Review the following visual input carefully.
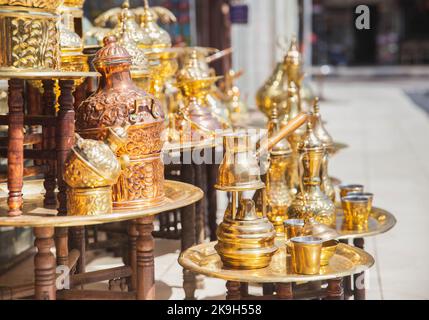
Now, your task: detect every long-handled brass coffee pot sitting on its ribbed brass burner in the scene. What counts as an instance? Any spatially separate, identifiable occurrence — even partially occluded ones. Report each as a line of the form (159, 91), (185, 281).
(215, 113), (308, 269)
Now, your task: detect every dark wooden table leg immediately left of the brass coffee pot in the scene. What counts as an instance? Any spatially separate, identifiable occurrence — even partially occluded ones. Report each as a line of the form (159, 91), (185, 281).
(206, 161), (219, 241)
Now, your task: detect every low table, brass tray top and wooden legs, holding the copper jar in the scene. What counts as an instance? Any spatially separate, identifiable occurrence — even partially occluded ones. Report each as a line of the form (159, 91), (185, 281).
(0, 180), (203, 300)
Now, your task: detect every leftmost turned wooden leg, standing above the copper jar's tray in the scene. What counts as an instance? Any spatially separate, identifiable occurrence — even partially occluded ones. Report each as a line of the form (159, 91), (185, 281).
(7, 79), (24, 216)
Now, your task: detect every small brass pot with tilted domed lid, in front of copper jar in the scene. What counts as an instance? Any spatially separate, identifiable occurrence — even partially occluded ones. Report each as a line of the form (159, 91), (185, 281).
(64, 128), (128, 216)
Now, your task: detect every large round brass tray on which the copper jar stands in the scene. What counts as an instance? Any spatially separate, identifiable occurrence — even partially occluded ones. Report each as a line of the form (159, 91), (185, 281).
(0, 180), (204, 227)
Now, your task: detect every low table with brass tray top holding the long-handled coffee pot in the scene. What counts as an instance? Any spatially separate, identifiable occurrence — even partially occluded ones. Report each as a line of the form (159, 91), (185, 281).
(179, 242), (374, 300)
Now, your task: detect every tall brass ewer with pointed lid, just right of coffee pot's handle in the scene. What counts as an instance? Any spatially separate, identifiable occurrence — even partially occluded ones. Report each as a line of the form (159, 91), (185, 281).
(288, 122), (336, 226)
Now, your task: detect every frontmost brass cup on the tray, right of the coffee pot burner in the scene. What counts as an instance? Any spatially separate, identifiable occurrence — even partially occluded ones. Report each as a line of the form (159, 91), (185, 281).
(291, 236), (323, 275)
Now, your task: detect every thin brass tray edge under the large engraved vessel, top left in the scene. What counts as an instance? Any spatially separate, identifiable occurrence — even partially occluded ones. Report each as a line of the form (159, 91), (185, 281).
(0, 71), (100, 80)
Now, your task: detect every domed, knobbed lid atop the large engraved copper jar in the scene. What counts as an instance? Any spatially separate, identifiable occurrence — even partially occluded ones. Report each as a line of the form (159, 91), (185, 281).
(93, 36), (132, 66)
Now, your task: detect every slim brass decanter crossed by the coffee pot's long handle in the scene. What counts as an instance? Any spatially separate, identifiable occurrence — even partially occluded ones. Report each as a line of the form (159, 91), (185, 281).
(266, 107), (293, 235)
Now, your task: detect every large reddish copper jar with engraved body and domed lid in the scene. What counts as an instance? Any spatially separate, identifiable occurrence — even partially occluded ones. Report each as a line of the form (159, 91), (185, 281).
(76, 36), (164, 208)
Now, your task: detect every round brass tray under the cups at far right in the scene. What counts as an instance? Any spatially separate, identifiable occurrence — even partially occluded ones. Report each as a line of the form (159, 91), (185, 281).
(337, 207), (396, 239)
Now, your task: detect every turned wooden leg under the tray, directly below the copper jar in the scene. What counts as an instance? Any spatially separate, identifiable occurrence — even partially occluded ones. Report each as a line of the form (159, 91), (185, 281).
(136, 216), (155, 300)
